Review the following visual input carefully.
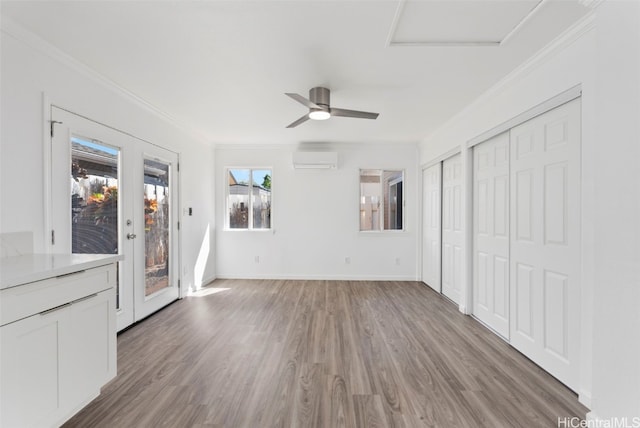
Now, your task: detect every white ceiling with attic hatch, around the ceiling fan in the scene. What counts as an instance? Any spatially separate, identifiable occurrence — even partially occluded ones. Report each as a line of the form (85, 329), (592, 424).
(1, 0), (587, 144)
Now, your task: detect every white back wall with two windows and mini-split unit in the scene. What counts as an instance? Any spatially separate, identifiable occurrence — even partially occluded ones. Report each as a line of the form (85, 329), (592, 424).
(215, 144), (419, 280)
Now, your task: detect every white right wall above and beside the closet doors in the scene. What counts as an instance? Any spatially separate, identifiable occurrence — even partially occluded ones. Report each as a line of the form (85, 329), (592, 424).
(420, 0), (640, 419)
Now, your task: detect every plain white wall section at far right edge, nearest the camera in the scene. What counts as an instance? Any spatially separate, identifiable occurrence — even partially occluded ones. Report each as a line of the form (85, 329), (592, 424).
(592, 1), (640, 424)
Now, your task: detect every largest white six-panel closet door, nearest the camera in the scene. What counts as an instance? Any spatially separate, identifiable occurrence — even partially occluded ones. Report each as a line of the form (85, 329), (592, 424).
(510, 100), (580, 390)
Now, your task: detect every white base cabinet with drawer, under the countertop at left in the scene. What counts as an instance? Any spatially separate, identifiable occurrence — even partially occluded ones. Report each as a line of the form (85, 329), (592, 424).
(0, 263), (116, 428)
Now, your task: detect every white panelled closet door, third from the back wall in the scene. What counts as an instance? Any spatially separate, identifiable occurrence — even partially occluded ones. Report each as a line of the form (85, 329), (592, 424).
(473, 132), (509, 339)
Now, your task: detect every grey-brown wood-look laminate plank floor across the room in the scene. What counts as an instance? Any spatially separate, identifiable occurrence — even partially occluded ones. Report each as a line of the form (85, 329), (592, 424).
(65, 280), (586, 428)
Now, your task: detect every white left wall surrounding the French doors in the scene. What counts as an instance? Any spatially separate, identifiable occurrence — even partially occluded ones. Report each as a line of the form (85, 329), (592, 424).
(0, 18), (215, 286)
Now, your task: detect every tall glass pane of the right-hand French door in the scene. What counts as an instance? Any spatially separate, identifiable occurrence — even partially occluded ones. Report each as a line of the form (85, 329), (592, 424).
(144, 159), (171, 297)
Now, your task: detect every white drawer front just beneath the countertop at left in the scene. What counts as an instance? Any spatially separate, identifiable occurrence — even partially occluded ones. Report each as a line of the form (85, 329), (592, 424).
(0, 264), (116, 325)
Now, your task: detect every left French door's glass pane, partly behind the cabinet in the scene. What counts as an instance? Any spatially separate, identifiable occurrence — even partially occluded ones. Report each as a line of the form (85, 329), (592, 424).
(71, 137), (120, 308)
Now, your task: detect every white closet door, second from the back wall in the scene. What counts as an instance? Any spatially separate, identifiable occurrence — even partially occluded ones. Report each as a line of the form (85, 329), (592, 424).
(442, 155), (464, 304)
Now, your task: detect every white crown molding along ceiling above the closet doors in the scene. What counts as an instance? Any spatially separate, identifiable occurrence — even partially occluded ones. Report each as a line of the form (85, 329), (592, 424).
(421, 8), (603, 144)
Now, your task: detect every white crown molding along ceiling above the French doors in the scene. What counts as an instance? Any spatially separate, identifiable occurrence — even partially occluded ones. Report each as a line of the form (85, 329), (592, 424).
(0, 15), (210, 144)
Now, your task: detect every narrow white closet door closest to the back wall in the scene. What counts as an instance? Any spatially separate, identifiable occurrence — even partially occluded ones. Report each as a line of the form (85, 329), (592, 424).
(422, 163), (441, 292)
